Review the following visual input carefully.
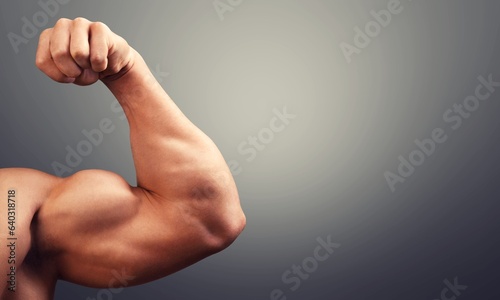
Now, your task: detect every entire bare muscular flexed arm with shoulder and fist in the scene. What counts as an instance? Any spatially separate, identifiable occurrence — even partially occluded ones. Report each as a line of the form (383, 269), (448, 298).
(0, 18), (246, 300)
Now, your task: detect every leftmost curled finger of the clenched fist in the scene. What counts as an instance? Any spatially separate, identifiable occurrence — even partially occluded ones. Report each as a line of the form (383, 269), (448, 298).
(36, 28), (75, 83)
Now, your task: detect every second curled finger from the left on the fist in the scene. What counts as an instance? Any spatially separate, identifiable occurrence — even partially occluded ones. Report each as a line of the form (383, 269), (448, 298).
(50, 19), (82, 78)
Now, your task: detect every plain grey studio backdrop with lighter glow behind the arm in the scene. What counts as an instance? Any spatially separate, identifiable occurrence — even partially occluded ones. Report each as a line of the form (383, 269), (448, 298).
(0, 0), (500, 300)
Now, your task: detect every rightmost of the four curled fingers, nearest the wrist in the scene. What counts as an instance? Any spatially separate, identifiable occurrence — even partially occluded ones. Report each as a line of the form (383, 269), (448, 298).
(90, 22), (111, 73)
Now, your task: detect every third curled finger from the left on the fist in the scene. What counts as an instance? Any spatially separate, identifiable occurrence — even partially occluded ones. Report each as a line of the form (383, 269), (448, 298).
(70, 18), (91, 69)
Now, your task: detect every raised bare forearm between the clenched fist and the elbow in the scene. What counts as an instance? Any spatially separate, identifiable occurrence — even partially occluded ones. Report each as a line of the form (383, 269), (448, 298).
(103, 51), (234, 196)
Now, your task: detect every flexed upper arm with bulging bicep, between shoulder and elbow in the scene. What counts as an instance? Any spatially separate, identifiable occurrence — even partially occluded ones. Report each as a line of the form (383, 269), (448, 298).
(37, 170), (223, 288)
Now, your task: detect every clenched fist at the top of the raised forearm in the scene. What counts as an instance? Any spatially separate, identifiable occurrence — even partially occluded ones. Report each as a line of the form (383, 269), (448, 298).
(36, 18), (135, 85)
